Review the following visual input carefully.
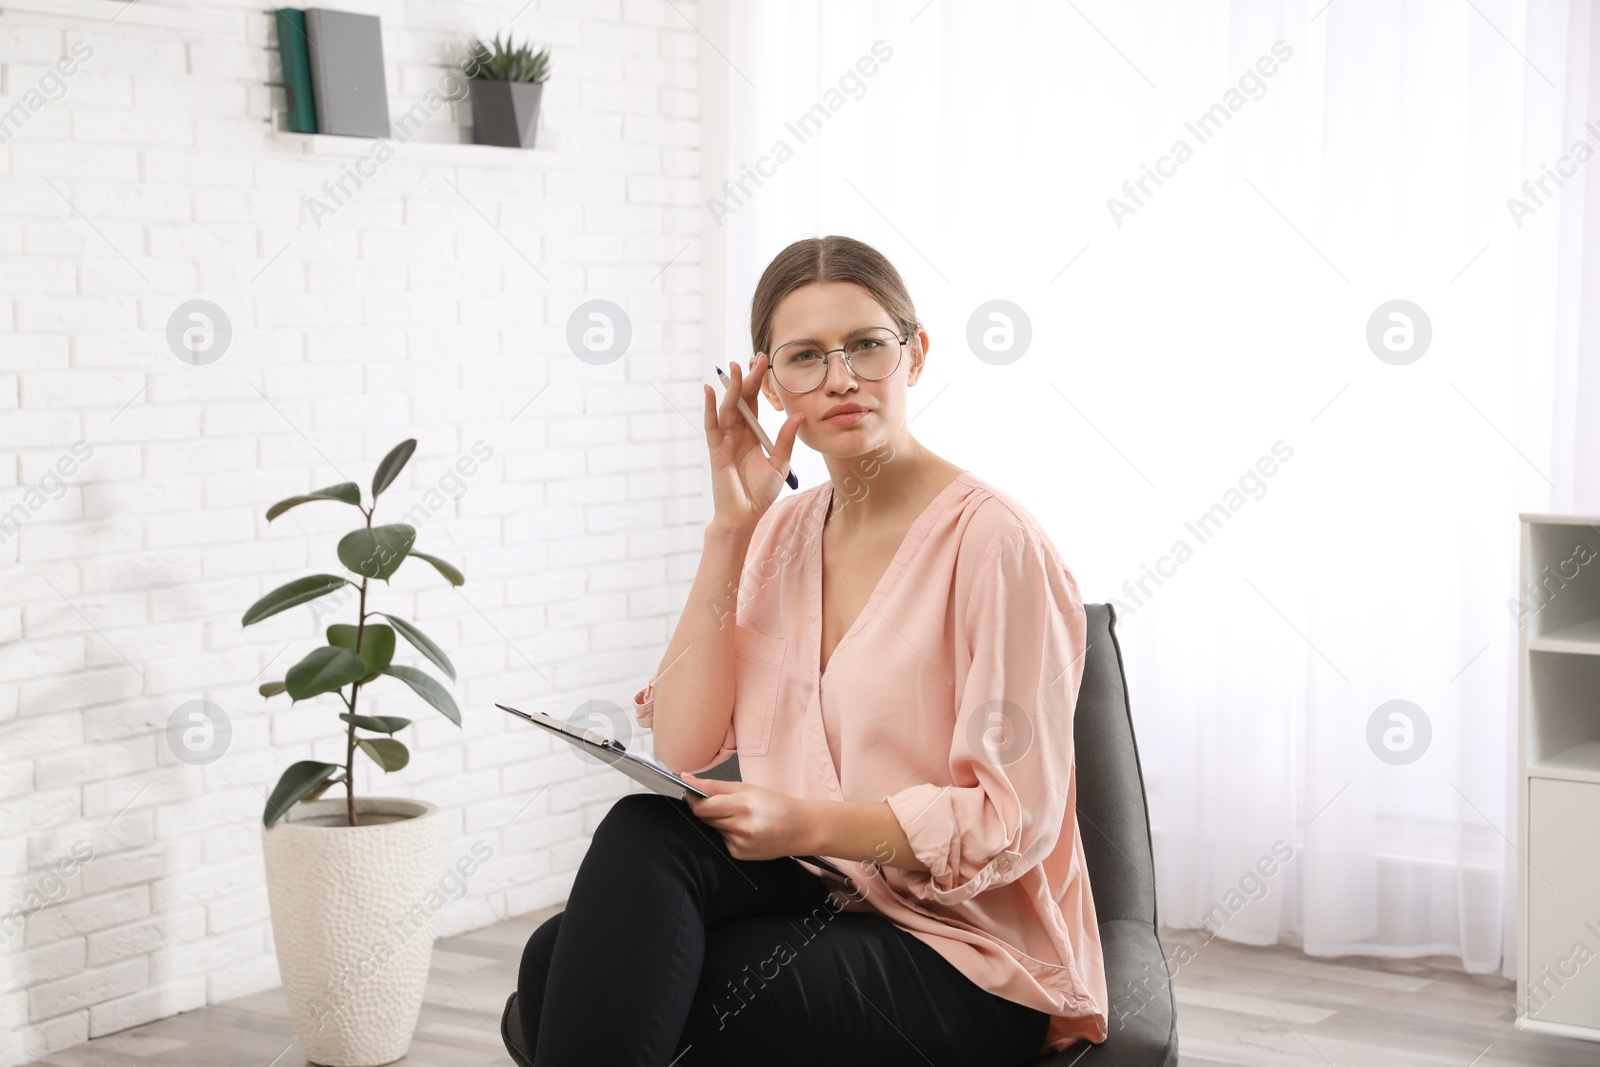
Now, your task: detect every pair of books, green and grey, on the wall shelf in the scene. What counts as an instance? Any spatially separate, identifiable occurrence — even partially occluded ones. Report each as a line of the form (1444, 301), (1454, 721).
(274, 8), (389, 138)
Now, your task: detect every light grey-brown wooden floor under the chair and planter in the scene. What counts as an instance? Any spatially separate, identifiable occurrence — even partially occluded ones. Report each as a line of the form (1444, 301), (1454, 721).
(15, 909), (1600, 1067)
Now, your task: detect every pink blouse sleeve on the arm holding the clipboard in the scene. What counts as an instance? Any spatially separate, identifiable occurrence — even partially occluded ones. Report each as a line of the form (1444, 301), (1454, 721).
(883, 530), (1088, 904)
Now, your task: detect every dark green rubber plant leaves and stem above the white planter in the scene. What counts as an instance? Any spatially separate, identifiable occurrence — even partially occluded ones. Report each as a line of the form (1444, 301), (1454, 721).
(242, 438), (466, 827)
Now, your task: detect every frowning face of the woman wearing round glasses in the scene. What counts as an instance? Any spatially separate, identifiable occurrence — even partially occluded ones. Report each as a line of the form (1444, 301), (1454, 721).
(762, 282), (928, 458)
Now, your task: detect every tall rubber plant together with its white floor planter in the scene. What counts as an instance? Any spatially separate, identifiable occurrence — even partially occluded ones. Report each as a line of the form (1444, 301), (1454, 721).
(242, 438), (466, 1067)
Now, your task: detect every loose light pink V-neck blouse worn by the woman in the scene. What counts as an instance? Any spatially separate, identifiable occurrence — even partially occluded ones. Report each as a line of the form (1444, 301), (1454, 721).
(634, 470), (1107, 1053)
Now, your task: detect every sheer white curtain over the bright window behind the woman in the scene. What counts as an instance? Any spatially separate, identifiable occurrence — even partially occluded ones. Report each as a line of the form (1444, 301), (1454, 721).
(701, 0), (1600, 974)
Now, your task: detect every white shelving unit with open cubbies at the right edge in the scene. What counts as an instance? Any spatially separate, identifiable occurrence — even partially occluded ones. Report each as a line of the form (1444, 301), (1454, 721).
(1514, 515), (1600, 1041)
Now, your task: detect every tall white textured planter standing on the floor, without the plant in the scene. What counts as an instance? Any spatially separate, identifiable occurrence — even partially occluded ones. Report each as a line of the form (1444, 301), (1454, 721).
(261, 797), (440, 1067)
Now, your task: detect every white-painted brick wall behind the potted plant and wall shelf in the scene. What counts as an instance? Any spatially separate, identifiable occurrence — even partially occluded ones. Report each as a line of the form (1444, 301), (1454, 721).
(0, 0), (706, 1067)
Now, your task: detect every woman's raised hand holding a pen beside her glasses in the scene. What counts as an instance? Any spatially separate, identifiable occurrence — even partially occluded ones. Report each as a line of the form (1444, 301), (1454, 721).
(706, 352), (805, 531)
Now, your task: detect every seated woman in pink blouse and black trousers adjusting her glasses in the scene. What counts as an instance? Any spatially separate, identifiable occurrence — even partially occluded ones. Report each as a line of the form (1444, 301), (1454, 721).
(504, 237), (1107, 1067)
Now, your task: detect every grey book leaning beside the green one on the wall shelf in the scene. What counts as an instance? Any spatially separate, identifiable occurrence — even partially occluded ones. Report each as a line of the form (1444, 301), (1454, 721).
(306, 8), (389, 138)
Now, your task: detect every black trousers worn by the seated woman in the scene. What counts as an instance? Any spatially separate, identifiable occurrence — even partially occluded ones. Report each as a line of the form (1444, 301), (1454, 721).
(517, 793), (1050, 1067)
